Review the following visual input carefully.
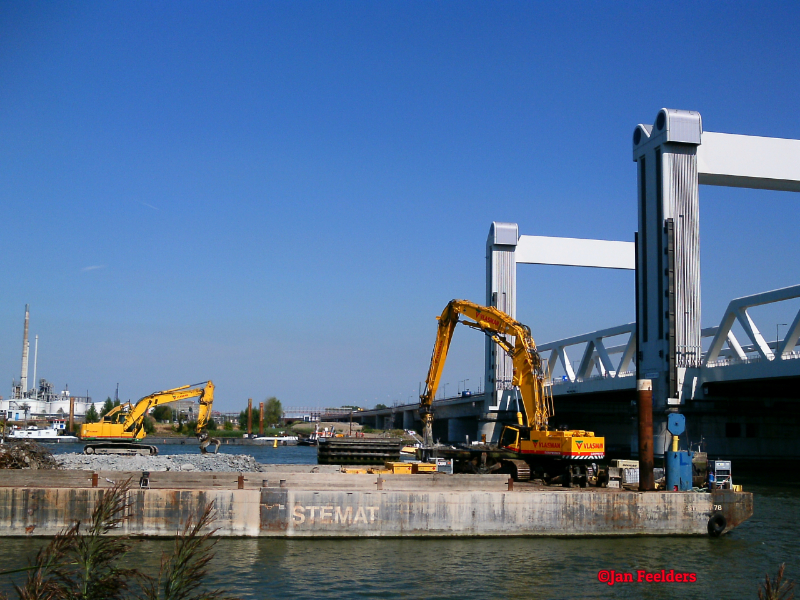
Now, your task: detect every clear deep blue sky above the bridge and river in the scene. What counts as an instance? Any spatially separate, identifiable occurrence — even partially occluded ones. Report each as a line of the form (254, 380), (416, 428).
(0, 1), (800, 410)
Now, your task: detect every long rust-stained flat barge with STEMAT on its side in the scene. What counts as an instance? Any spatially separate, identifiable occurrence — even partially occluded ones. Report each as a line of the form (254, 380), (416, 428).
(0, 465), (753, 538)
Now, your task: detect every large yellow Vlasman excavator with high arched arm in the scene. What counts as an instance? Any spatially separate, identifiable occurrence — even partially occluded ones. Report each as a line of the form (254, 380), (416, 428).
(419, 300), (605, 485)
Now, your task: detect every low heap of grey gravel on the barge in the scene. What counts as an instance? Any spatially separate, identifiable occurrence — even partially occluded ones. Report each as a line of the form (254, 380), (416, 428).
(55, 453), (263, 472)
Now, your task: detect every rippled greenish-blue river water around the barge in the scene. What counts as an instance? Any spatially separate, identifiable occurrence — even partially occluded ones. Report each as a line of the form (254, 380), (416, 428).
(0, 444), (800, 600)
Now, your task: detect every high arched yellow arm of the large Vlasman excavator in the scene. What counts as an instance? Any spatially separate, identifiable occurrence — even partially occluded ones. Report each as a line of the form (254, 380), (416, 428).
(419, 300), (553, 446)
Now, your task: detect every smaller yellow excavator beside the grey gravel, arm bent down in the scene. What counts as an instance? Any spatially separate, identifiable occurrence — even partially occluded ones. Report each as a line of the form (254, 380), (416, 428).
(80, 381), (220, 455)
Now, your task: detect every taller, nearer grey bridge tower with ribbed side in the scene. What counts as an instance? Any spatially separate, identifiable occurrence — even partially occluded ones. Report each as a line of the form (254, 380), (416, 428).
(633, 109), (703, 448)
